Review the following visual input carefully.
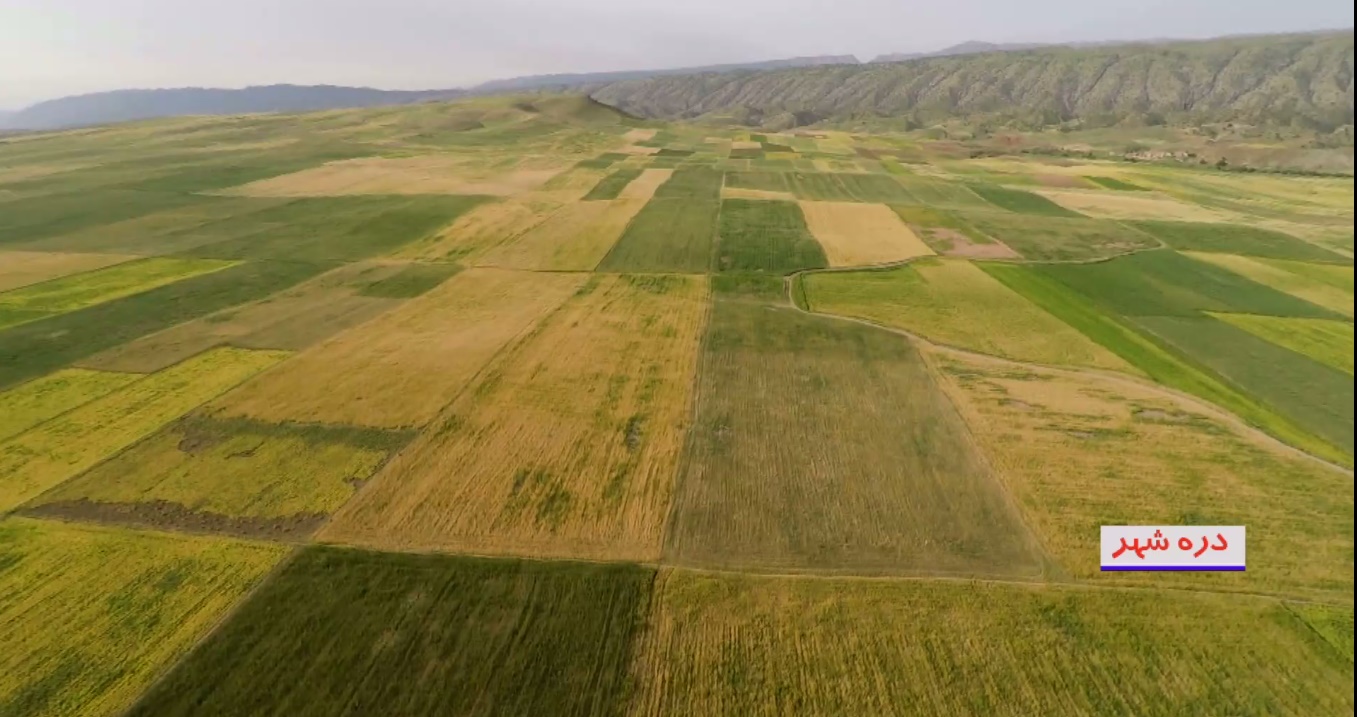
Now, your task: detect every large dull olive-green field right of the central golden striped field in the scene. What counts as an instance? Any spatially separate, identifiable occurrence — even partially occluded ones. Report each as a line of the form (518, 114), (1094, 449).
(665, 300), (1038, 574)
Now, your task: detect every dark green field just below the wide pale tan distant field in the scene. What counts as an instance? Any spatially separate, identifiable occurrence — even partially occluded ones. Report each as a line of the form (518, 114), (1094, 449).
(186, 196), (487, 262)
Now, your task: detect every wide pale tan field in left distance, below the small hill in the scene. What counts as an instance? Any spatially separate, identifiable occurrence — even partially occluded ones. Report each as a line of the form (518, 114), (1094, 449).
(224, 155), (560, 197)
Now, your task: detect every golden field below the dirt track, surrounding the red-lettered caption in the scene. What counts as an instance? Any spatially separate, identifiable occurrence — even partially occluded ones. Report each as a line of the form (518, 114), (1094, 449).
(934, 353), (1353, 599)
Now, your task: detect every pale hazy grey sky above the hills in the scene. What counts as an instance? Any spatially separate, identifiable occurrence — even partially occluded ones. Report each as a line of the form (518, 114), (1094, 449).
(0, 0), (1353, 109)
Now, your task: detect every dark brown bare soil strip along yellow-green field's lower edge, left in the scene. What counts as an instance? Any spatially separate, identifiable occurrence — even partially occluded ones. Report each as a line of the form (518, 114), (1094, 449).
(23, 498), (328, 540)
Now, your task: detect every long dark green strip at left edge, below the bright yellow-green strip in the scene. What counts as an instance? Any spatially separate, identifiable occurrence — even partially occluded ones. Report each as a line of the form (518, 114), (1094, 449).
(0, 262), (328, 387)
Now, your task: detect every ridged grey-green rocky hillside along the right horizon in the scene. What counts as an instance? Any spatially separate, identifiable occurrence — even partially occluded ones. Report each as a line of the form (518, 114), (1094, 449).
(593, 31), (1353, 130)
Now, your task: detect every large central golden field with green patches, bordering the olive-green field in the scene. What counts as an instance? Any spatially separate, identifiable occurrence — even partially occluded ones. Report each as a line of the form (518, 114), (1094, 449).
(320, 276), (707, 559)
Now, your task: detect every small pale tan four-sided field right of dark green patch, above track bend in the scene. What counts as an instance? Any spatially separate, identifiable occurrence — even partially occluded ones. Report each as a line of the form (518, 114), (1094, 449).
(799, 201), (934, 266)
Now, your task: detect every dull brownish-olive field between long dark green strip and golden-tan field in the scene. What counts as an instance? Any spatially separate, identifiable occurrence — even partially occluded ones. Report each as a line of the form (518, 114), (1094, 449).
(77, 262), (402, 373)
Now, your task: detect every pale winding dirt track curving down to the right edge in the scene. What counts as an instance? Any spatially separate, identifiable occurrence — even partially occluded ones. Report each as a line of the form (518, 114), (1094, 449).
(783, 262), (1354, 478)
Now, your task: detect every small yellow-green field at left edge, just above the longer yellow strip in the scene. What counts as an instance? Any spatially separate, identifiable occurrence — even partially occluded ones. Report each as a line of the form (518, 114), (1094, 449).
(0, 368), (141, 441)
